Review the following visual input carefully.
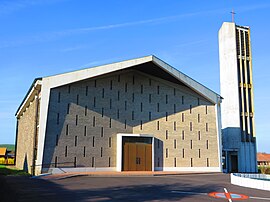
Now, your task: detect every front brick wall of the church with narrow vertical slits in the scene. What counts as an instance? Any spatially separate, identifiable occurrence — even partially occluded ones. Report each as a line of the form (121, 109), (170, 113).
(43, 70), (219, 172)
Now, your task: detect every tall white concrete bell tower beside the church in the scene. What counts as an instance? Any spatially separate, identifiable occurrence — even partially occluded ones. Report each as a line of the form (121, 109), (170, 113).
(219, 22), (257, 172)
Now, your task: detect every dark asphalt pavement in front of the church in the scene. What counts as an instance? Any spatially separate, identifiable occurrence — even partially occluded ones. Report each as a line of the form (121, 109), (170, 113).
(0, 174), (270, 202)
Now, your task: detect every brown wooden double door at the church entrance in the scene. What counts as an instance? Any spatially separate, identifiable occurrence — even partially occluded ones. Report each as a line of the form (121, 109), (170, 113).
(123, 142), (152, 171)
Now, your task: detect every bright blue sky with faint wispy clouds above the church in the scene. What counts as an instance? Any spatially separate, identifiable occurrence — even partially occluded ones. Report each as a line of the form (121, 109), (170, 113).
(0, 0), (270, 153)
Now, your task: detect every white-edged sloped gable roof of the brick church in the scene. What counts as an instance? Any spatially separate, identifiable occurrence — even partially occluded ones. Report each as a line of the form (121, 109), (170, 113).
(16, 55), (222, 116)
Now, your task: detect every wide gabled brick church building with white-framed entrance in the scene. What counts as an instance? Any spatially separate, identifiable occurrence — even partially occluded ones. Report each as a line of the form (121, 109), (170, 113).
(13, 55), (223, 175)
